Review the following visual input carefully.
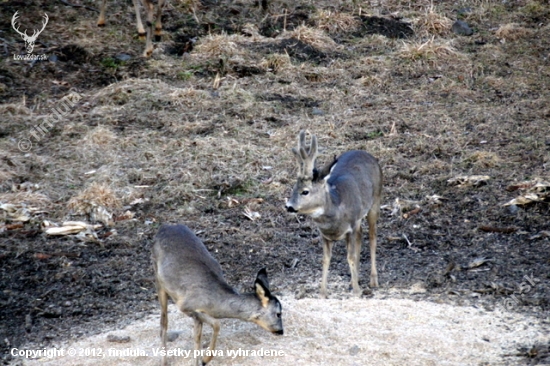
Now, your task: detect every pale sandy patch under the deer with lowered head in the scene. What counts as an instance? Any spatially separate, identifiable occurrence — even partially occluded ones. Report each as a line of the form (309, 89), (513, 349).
(18, 297), (550, 365)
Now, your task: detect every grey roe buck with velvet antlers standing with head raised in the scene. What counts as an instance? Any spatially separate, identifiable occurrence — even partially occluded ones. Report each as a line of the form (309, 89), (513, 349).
(286, 131), (382, 298)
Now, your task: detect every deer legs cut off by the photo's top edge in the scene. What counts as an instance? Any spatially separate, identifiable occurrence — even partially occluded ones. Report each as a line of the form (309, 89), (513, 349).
(97, 0), (165, 57)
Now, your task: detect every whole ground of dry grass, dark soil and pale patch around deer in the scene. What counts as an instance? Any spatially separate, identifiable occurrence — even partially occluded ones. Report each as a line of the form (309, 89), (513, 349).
(0, 0), (550, 365)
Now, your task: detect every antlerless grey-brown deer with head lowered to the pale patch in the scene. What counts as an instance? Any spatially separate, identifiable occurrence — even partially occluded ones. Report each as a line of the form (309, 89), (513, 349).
(151, 225), (283, 366)
